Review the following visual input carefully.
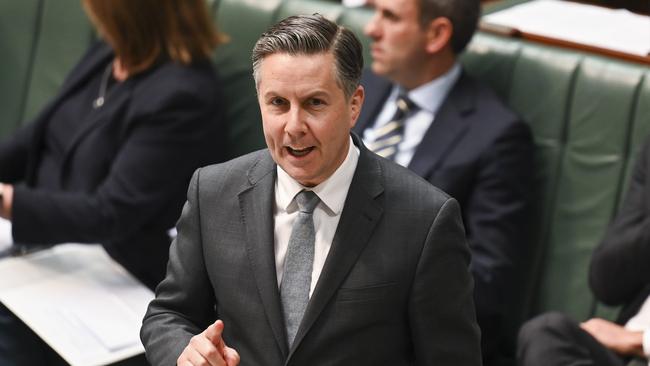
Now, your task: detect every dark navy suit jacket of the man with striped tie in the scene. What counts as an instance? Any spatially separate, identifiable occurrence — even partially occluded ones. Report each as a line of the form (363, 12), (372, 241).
(355, 71), (533, 357)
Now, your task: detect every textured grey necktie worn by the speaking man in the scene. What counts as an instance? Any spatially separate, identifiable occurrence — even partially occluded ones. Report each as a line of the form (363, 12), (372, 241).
(280, 191), (319, 346)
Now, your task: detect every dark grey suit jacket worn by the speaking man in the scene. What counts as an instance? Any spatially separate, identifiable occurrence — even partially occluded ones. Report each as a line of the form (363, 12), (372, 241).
(141, 136), (481, 366)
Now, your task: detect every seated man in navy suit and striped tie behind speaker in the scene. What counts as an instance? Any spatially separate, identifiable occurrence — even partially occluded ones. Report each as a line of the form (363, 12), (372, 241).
(354, 0), (533, 364)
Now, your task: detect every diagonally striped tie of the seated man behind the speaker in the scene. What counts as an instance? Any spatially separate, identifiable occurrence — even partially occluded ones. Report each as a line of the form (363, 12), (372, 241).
(369, 92), (418, 160)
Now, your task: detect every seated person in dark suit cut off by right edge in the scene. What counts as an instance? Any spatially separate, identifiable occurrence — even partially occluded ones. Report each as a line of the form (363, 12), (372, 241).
(518, 140), (650, 366)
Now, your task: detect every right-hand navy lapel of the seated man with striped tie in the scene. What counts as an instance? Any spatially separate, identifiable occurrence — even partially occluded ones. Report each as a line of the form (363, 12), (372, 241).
(408, 73), (476, 177)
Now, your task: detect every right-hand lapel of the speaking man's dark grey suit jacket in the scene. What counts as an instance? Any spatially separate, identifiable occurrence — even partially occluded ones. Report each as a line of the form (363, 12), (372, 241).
(288, 135), (383, 359)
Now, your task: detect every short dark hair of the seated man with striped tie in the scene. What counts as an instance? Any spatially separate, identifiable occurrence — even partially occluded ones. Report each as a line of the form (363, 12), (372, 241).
(418, 0), (481, 55)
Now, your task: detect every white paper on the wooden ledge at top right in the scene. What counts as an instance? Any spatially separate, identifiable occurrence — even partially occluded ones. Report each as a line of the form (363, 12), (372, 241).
(481, 0), (650, 56)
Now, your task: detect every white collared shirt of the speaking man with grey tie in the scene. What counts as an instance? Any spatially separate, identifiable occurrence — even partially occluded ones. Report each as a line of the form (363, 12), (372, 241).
(274, 138), (359, 297)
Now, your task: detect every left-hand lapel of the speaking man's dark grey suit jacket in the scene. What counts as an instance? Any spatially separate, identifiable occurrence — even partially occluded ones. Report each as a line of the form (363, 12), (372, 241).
(239, 154), (288, 356)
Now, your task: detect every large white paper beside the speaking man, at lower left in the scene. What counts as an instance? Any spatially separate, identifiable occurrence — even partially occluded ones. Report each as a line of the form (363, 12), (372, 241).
(0, 244), (154, 366)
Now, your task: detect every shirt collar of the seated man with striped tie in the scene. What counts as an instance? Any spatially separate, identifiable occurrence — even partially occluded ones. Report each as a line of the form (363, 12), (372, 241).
(391, 62), (461, 115)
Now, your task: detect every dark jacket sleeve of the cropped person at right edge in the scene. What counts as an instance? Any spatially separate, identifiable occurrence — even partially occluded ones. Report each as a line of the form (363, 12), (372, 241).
(589, 139), (650, 324)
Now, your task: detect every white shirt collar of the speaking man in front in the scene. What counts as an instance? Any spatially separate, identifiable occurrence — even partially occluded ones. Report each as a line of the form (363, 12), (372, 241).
(275, 137), (359, 215)
